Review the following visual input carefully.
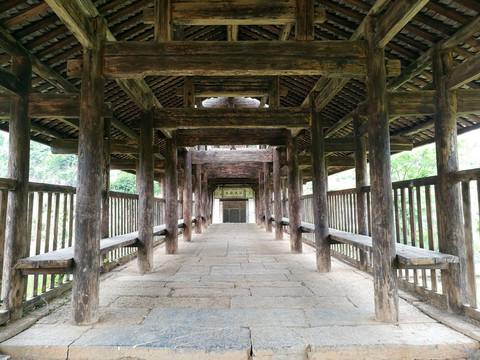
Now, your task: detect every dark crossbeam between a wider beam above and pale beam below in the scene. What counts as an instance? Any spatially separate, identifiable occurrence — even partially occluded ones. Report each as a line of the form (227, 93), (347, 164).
(177, 129), (289, 146)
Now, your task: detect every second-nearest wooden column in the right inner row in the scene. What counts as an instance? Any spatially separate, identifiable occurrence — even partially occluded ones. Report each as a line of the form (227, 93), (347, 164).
(310, 100), (331, 272)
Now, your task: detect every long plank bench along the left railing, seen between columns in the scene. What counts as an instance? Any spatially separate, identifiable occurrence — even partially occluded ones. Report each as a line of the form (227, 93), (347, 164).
(15, 219), (185, 275)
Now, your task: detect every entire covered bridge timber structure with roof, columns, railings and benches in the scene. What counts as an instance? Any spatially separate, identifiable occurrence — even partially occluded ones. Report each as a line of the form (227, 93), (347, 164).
(0, 0), (480, 352)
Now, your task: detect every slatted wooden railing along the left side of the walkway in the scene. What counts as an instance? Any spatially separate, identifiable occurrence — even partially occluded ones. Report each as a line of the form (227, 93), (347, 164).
(0, 179), (172, 316)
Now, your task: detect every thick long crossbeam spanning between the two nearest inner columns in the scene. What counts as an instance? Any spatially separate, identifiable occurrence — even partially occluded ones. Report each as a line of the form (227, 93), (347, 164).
(104, 41), (366, 79)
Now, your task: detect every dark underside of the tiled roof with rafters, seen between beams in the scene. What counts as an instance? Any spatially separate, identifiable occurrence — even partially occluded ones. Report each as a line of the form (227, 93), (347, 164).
(0, 0), (480, 173)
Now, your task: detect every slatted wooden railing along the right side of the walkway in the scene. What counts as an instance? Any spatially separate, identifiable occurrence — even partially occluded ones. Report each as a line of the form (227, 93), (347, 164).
(302, 169), (480, 318)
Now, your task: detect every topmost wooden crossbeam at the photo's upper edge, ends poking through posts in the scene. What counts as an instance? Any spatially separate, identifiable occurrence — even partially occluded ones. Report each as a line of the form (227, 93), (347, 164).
(143, 0), (326, 26)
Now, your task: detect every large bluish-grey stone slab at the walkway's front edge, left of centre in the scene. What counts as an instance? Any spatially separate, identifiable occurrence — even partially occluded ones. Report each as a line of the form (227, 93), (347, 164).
(68, 325), (251, 360)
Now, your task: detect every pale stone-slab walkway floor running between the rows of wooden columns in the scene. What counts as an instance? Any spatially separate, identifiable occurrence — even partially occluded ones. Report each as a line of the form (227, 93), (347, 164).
(0, 224), (480, 360)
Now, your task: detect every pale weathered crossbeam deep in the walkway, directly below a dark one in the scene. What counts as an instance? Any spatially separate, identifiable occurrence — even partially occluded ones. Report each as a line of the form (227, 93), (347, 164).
(192, 149), (272, 164)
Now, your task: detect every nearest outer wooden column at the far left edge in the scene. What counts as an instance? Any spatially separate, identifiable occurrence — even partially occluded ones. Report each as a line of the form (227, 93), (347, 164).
(2, 57), (32, 320)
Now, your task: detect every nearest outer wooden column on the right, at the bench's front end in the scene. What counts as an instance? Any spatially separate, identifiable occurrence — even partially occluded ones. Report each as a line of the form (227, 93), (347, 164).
(433, 51), (468, 313)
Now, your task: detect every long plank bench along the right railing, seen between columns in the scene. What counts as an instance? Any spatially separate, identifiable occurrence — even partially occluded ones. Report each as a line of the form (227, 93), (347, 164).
(272, 218), (459, 269)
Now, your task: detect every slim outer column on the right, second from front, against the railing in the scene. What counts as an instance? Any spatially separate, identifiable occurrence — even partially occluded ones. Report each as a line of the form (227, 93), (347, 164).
(353, 115), (368, 271)
